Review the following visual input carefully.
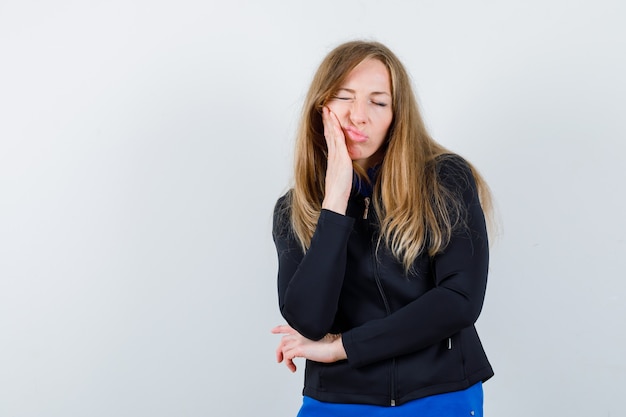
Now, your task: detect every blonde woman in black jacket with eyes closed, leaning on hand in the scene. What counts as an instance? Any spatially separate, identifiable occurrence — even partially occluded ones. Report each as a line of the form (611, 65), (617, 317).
(272, 41), (493, 417)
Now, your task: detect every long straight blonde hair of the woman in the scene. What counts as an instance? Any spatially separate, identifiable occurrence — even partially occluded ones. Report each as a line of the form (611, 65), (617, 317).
(289, 41), (491, 272)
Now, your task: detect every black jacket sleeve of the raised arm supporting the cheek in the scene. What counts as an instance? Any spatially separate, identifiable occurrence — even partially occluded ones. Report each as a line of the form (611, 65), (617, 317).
(272, 195), (354, 340)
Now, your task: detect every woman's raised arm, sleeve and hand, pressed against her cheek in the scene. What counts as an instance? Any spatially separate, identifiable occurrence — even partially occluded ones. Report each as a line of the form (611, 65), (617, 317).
(273, 107), (354, 340)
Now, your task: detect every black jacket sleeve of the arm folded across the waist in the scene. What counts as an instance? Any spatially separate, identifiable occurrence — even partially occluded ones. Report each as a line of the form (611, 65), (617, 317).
(342, 158), (489, 367)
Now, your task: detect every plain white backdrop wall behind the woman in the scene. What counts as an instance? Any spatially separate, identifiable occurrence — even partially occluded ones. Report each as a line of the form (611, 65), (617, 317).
(0, 0), (626, 417)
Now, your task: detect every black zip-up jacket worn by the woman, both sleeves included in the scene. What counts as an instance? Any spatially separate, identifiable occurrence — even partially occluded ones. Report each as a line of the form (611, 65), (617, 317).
(273, 156), (493, 405)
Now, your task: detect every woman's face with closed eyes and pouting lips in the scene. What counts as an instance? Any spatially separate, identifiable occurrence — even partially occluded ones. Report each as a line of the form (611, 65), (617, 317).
(327, 59), (393, 169)
